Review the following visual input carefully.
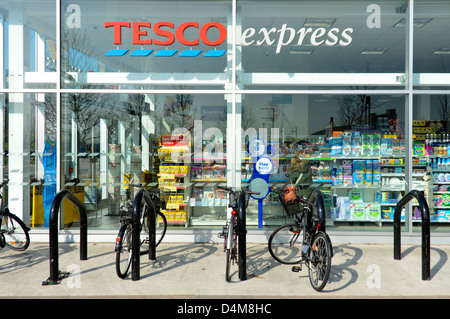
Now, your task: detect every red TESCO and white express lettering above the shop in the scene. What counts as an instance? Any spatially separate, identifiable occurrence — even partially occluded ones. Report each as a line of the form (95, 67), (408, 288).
(104, 21), (353, 54)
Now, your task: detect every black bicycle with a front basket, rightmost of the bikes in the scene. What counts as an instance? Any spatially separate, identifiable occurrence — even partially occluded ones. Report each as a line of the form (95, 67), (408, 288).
(268, 186), (333, 291)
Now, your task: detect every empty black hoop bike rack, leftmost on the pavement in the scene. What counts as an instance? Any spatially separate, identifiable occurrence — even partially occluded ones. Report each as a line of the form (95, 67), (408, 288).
(42, 189), (87, 286)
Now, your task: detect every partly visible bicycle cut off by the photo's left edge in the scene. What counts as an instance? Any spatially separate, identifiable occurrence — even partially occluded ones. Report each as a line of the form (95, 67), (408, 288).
(0, 179), (30, 251)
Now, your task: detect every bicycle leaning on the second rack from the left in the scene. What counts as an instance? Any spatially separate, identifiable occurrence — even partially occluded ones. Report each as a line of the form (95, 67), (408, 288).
(115, 184), (167, 279)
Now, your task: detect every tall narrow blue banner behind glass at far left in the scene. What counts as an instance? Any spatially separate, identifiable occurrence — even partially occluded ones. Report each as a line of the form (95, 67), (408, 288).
(42, 134), (56, 227)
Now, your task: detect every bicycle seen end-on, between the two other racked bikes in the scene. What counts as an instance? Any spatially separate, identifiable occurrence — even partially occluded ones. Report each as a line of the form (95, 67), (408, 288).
(218, 186), (259, 282)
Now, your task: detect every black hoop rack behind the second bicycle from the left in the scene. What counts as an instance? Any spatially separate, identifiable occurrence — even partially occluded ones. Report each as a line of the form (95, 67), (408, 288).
(131, 189), (156, 281)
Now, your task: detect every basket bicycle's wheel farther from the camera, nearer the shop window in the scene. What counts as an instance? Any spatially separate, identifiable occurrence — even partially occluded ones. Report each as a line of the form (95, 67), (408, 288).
(268, 223), (303, 265)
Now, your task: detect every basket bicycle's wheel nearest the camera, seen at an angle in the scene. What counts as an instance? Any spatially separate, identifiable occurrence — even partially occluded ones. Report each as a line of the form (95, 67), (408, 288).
(308, 232), (332, 291)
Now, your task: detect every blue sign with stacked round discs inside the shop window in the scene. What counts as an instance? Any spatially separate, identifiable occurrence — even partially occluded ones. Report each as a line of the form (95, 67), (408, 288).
(248, 138), (274, 228)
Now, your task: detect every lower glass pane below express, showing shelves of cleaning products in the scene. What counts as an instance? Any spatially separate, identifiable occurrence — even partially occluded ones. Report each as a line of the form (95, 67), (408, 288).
(241, 94), (408, 231)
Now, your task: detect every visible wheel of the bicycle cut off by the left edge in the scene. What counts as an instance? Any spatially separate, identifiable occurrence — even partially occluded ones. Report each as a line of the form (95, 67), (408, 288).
(0, 211), (30, 251)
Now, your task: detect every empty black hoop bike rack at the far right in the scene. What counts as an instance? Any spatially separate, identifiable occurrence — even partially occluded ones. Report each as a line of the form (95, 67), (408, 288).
(394, 190), (431, 280)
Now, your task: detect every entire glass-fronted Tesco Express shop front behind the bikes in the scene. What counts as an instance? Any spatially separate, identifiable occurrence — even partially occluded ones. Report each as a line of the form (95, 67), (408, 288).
(0, 0), (450, 243)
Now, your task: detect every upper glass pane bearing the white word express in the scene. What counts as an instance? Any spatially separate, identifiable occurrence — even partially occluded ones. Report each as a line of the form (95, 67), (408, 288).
(237, 1), (406, 89)
